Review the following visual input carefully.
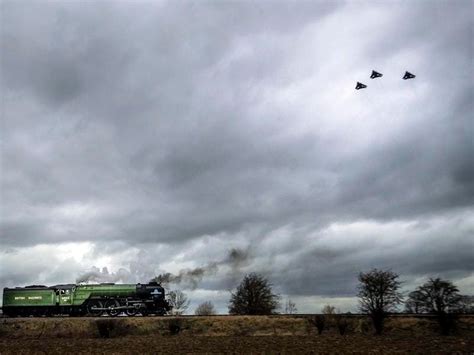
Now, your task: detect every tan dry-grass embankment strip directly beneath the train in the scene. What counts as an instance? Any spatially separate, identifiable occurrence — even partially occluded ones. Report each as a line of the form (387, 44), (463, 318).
(0, 315), (474, 339)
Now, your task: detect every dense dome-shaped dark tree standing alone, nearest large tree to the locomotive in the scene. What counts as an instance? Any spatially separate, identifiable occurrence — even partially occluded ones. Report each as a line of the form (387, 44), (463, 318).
(229, 273), (279, 314)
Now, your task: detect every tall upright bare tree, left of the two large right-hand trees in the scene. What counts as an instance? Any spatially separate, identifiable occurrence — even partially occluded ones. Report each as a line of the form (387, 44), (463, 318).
(358, 269), (403, 335)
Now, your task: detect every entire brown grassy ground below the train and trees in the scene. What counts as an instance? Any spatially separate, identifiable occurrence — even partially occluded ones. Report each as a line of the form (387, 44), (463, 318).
(0, 316), (474, 354)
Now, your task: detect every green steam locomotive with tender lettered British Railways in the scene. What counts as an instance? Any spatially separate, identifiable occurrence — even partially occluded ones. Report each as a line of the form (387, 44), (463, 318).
(2, 282), (172, 317)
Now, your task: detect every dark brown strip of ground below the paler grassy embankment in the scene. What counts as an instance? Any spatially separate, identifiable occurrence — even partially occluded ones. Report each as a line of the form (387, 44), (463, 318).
(0, 333), (474, 354)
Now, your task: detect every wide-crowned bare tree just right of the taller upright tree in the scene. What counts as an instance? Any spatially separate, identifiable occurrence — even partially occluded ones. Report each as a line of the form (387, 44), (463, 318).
(408, 278), (462, 335)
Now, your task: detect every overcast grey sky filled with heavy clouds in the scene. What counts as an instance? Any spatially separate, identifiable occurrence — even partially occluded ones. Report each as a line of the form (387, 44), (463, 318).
(0, 0), (474, 313)
